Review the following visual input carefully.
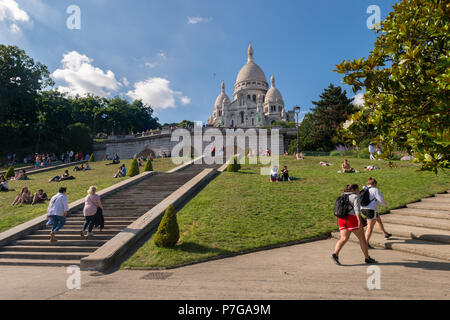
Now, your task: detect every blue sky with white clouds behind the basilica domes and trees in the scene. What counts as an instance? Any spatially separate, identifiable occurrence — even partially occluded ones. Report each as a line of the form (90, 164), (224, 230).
(0, 0), (396, 123)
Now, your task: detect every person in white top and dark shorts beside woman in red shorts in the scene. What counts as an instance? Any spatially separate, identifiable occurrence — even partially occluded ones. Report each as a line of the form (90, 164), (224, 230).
(360, 178), (392, 249)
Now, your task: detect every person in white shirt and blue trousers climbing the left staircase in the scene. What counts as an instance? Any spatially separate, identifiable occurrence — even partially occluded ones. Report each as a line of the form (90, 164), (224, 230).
(47, 188), (69, 242)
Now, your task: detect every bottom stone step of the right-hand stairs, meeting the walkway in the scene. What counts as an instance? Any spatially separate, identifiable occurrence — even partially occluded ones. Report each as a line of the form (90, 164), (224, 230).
(332, 232), (450, 261)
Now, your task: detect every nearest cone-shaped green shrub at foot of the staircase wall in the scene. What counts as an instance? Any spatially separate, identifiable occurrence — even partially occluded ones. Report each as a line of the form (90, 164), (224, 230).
(154, 205), (180, 248)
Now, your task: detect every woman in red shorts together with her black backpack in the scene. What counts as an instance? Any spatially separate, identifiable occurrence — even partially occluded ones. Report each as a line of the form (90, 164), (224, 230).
(331, 184), (377, 265)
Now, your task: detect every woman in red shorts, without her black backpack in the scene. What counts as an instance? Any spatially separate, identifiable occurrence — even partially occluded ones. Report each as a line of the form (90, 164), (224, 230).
(332, 184), (377, 265)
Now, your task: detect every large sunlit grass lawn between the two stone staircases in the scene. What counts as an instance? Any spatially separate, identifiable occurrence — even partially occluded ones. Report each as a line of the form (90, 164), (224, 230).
(122, 157), (450, 268)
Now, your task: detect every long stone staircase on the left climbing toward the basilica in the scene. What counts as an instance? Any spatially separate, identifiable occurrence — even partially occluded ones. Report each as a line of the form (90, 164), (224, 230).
(0, 165), (218, 267)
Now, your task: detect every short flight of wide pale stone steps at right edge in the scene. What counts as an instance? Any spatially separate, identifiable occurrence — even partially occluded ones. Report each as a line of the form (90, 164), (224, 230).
(332, 190), (450, 261)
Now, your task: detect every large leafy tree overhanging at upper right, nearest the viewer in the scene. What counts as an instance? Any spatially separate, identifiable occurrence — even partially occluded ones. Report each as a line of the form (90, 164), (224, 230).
(336, 0), (450, 173)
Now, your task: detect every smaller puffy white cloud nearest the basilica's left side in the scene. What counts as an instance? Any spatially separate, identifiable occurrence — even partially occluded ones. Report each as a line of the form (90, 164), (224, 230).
(127, 78), (191, 109)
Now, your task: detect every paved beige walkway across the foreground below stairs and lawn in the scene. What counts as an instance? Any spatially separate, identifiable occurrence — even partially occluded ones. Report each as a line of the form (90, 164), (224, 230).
(0, 240), (450, 300)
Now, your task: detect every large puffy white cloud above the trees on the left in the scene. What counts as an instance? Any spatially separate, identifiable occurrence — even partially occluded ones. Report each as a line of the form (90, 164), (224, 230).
(52, 51), (121, 97)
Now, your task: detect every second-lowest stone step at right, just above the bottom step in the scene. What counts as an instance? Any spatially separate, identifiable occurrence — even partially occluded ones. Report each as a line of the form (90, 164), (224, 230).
(373, 223), (450, 244)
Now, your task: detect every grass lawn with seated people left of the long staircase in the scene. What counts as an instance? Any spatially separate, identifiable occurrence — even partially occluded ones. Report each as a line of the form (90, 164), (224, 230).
(0, 158), (176, 232)
